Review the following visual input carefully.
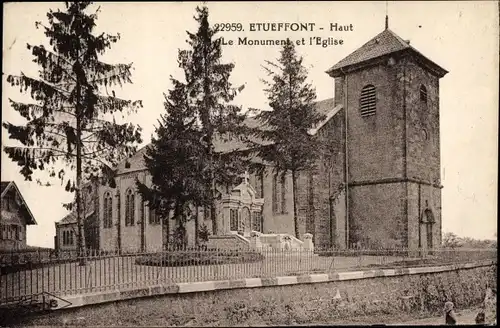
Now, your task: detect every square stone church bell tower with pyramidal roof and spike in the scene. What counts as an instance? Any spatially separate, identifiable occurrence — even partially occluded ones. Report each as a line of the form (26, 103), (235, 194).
(327, 21), (447, 249)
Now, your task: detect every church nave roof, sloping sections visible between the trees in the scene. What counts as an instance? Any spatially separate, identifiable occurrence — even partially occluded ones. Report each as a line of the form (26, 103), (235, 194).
(117, 98), (338, 174)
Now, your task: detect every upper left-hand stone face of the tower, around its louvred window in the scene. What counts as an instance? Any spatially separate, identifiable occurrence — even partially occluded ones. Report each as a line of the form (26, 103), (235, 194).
(345, 65), (405, 182)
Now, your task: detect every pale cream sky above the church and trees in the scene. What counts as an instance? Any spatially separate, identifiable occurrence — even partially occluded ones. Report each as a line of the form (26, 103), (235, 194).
(1, 1), (499, 247)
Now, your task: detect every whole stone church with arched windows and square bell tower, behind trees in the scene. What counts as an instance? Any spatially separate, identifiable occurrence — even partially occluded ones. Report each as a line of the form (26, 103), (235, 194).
(55, 21), (448, 251)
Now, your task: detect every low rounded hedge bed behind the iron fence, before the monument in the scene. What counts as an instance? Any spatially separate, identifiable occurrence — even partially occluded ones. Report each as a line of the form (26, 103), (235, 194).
(135, 249), (264, 267)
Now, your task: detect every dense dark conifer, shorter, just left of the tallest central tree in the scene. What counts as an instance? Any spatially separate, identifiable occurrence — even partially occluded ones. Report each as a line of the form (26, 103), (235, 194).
(137, 79), (209, 246)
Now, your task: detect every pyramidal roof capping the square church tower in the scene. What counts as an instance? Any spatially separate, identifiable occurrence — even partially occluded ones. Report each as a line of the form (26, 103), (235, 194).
(326, 28), (448, 77)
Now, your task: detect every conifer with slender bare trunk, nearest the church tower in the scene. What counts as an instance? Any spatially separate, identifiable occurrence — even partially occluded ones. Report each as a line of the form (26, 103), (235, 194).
(254, 40), (324, 238)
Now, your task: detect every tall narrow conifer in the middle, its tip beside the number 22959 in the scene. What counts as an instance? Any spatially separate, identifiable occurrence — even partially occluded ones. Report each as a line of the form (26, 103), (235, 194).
(180, 7), (248, 234)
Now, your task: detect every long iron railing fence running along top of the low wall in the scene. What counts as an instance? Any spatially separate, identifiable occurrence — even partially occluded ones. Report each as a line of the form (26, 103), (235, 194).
(0, 248), (497, 304)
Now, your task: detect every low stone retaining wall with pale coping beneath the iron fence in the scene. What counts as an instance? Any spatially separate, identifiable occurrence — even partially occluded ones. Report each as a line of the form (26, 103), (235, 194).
(16, 261), (497, 326)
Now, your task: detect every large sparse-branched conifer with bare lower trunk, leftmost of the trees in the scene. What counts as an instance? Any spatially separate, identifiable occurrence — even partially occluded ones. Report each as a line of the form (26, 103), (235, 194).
(3, 2), (142, 258)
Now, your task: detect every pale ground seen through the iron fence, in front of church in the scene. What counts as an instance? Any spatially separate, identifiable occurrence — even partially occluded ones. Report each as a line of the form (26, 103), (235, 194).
(0, 252), (401, 303)
